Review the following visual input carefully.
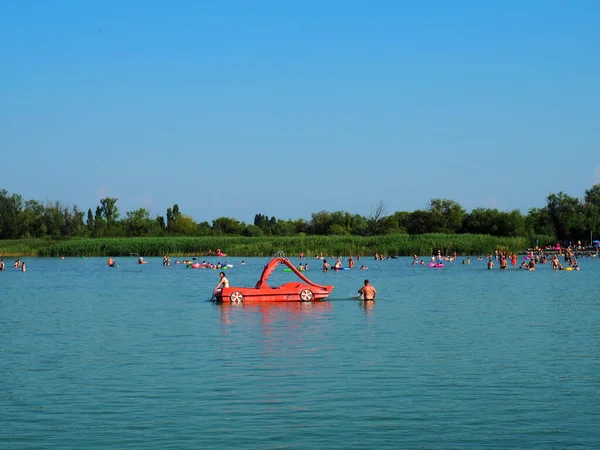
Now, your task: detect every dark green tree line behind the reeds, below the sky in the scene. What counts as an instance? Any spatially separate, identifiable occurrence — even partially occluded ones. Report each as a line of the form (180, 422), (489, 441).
(0, 184), (600, 242)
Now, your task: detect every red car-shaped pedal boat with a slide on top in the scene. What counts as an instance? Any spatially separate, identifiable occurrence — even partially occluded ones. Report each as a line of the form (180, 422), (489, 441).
(214, 256), (333, 303)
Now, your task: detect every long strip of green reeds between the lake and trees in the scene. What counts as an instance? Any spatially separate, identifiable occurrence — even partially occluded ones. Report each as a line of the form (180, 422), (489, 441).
(5, 234), (535, 257)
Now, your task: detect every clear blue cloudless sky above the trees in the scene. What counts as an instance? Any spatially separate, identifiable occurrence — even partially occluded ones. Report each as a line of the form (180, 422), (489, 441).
(0, 0), (600, 222)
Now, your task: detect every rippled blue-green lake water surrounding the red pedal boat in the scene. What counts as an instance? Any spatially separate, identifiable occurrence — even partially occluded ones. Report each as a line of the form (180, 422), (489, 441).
(0, 258), (600, 449)
